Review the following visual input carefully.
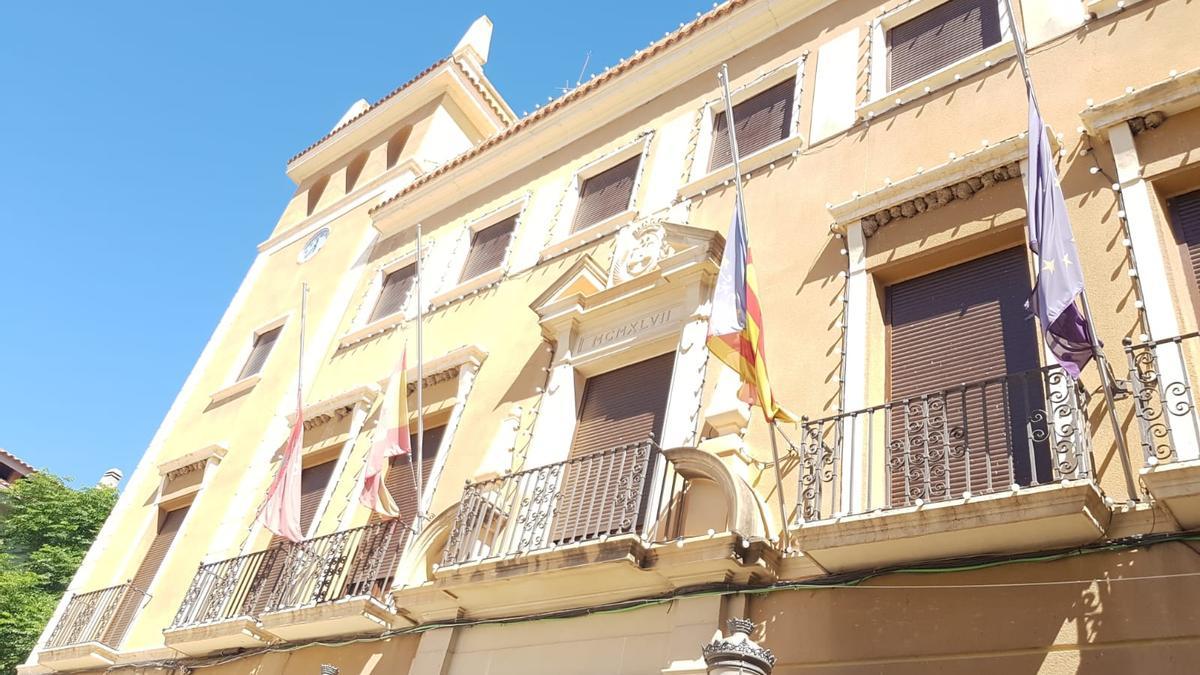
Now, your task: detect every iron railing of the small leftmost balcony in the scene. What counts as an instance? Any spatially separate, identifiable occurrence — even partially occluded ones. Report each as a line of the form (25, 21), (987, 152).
(46, 584), (146, 650)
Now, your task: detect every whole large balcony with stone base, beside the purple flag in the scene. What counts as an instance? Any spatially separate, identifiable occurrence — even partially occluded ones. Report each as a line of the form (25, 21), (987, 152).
(792, 366), (1110, 572)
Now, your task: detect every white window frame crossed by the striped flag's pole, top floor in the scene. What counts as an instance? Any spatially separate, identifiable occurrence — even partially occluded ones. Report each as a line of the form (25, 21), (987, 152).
(679, 52), (808, 199)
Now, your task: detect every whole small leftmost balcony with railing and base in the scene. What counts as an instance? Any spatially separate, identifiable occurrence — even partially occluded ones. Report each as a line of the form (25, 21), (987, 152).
(37, 584), (146, 670)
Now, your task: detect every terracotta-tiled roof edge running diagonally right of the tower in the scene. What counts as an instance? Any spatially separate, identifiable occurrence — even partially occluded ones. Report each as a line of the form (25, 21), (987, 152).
(371, 0), (750, 213)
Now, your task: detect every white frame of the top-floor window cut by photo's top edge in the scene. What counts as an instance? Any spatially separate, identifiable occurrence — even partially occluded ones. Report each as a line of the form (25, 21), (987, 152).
(858, 0), (1016, 119)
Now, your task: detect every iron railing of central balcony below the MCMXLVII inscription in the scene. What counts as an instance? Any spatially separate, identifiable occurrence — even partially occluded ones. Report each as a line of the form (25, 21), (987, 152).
(442, 441), (686, 566)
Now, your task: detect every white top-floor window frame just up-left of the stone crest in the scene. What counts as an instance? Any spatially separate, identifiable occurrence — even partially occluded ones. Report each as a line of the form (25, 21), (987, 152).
(541, 132), (654, 261)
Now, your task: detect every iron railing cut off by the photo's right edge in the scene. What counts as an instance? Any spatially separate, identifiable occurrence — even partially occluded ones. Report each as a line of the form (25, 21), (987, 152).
(1124, 333), (1200, 466)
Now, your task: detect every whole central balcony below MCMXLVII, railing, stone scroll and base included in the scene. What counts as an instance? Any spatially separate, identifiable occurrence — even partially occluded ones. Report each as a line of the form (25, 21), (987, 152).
(395, 441), (761, 621)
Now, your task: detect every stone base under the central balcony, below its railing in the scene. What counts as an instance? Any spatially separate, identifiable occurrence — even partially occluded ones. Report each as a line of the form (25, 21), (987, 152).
(394, 533), (769, 623)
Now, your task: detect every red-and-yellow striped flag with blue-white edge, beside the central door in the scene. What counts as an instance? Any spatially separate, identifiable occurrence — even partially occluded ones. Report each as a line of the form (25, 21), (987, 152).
(708, 194), (796, 422)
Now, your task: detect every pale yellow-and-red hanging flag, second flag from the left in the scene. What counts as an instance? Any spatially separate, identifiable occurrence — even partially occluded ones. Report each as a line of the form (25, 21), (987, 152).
(359, 347), (413, 518)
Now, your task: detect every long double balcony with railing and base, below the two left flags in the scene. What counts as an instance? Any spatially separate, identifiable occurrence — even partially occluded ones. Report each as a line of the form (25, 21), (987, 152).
(164, 520), (408, 653)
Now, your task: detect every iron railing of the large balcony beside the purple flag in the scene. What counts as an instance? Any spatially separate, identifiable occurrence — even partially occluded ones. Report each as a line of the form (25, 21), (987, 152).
(797, 366), (1092, 521)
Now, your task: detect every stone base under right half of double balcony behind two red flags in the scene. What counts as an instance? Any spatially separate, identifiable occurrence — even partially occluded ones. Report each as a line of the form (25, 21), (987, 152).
(262, 597), (401, 641)
